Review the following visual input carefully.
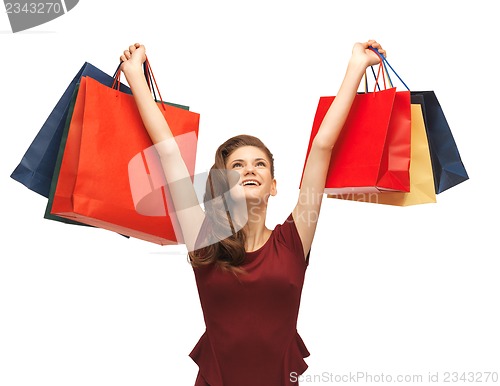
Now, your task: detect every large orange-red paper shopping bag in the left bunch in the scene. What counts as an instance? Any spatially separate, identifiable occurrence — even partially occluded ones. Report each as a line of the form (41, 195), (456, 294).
(51, 61), (199, 245)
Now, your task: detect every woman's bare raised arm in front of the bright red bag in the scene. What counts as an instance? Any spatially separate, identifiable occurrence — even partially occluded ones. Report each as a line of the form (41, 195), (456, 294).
(293, 40), (385, 256)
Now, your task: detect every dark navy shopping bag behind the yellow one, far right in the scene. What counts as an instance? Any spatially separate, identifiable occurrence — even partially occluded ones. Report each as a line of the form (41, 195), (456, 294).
(411, 91), (469, 194)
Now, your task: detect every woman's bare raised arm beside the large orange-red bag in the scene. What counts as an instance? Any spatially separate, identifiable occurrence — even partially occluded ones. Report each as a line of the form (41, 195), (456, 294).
(120, 43), (205, 251)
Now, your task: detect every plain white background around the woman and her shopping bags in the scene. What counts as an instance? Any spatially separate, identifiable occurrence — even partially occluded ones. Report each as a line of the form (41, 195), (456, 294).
(0, 0), (500, 386)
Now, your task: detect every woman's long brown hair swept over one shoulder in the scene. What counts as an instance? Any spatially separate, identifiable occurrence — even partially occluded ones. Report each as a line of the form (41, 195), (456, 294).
(188, 135), (274, 273)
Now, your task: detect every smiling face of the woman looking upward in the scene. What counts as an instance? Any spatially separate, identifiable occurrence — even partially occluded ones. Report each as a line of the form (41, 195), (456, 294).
(226, 146), (277, 205)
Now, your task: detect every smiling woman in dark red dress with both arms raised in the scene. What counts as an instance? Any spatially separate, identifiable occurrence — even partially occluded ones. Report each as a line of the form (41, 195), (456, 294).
(120, 40), (385, 386)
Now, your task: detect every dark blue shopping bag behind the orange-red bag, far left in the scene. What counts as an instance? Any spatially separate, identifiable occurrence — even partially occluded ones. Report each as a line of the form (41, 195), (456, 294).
(11, 62), (131, 198)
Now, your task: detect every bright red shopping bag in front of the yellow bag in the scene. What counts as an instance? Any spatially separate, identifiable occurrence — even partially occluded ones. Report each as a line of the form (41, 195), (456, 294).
(304, 64), (411, 194)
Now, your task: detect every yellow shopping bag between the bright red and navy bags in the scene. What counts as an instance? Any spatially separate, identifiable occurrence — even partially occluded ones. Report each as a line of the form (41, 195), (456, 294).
(327, 103), (436, 206)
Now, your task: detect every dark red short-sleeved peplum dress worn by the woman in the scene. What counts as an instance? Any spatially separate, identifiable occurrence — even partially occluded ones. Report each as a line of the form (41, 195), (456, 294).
(189, 215), (309, 386)
